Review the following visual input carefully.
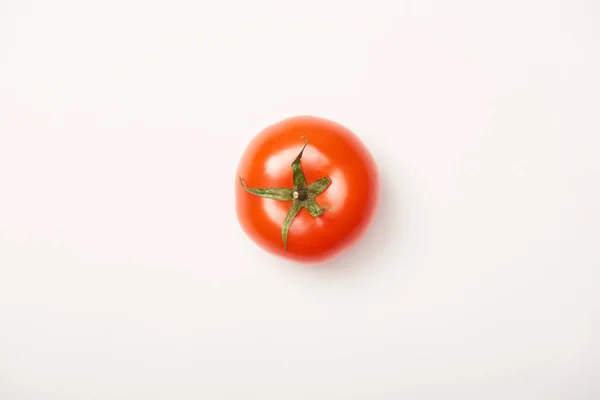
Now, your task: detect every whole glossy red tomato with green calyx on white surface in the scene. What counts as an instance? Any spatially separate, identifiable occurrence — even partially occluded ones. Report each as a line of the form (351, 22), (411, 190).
(235, 116), (379, 264)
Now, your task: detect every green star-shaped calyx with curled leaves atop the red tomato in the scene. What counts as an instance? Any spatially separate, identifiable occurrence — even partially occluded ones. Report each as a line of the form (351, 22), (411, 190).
(239, 136), (331, 251)
